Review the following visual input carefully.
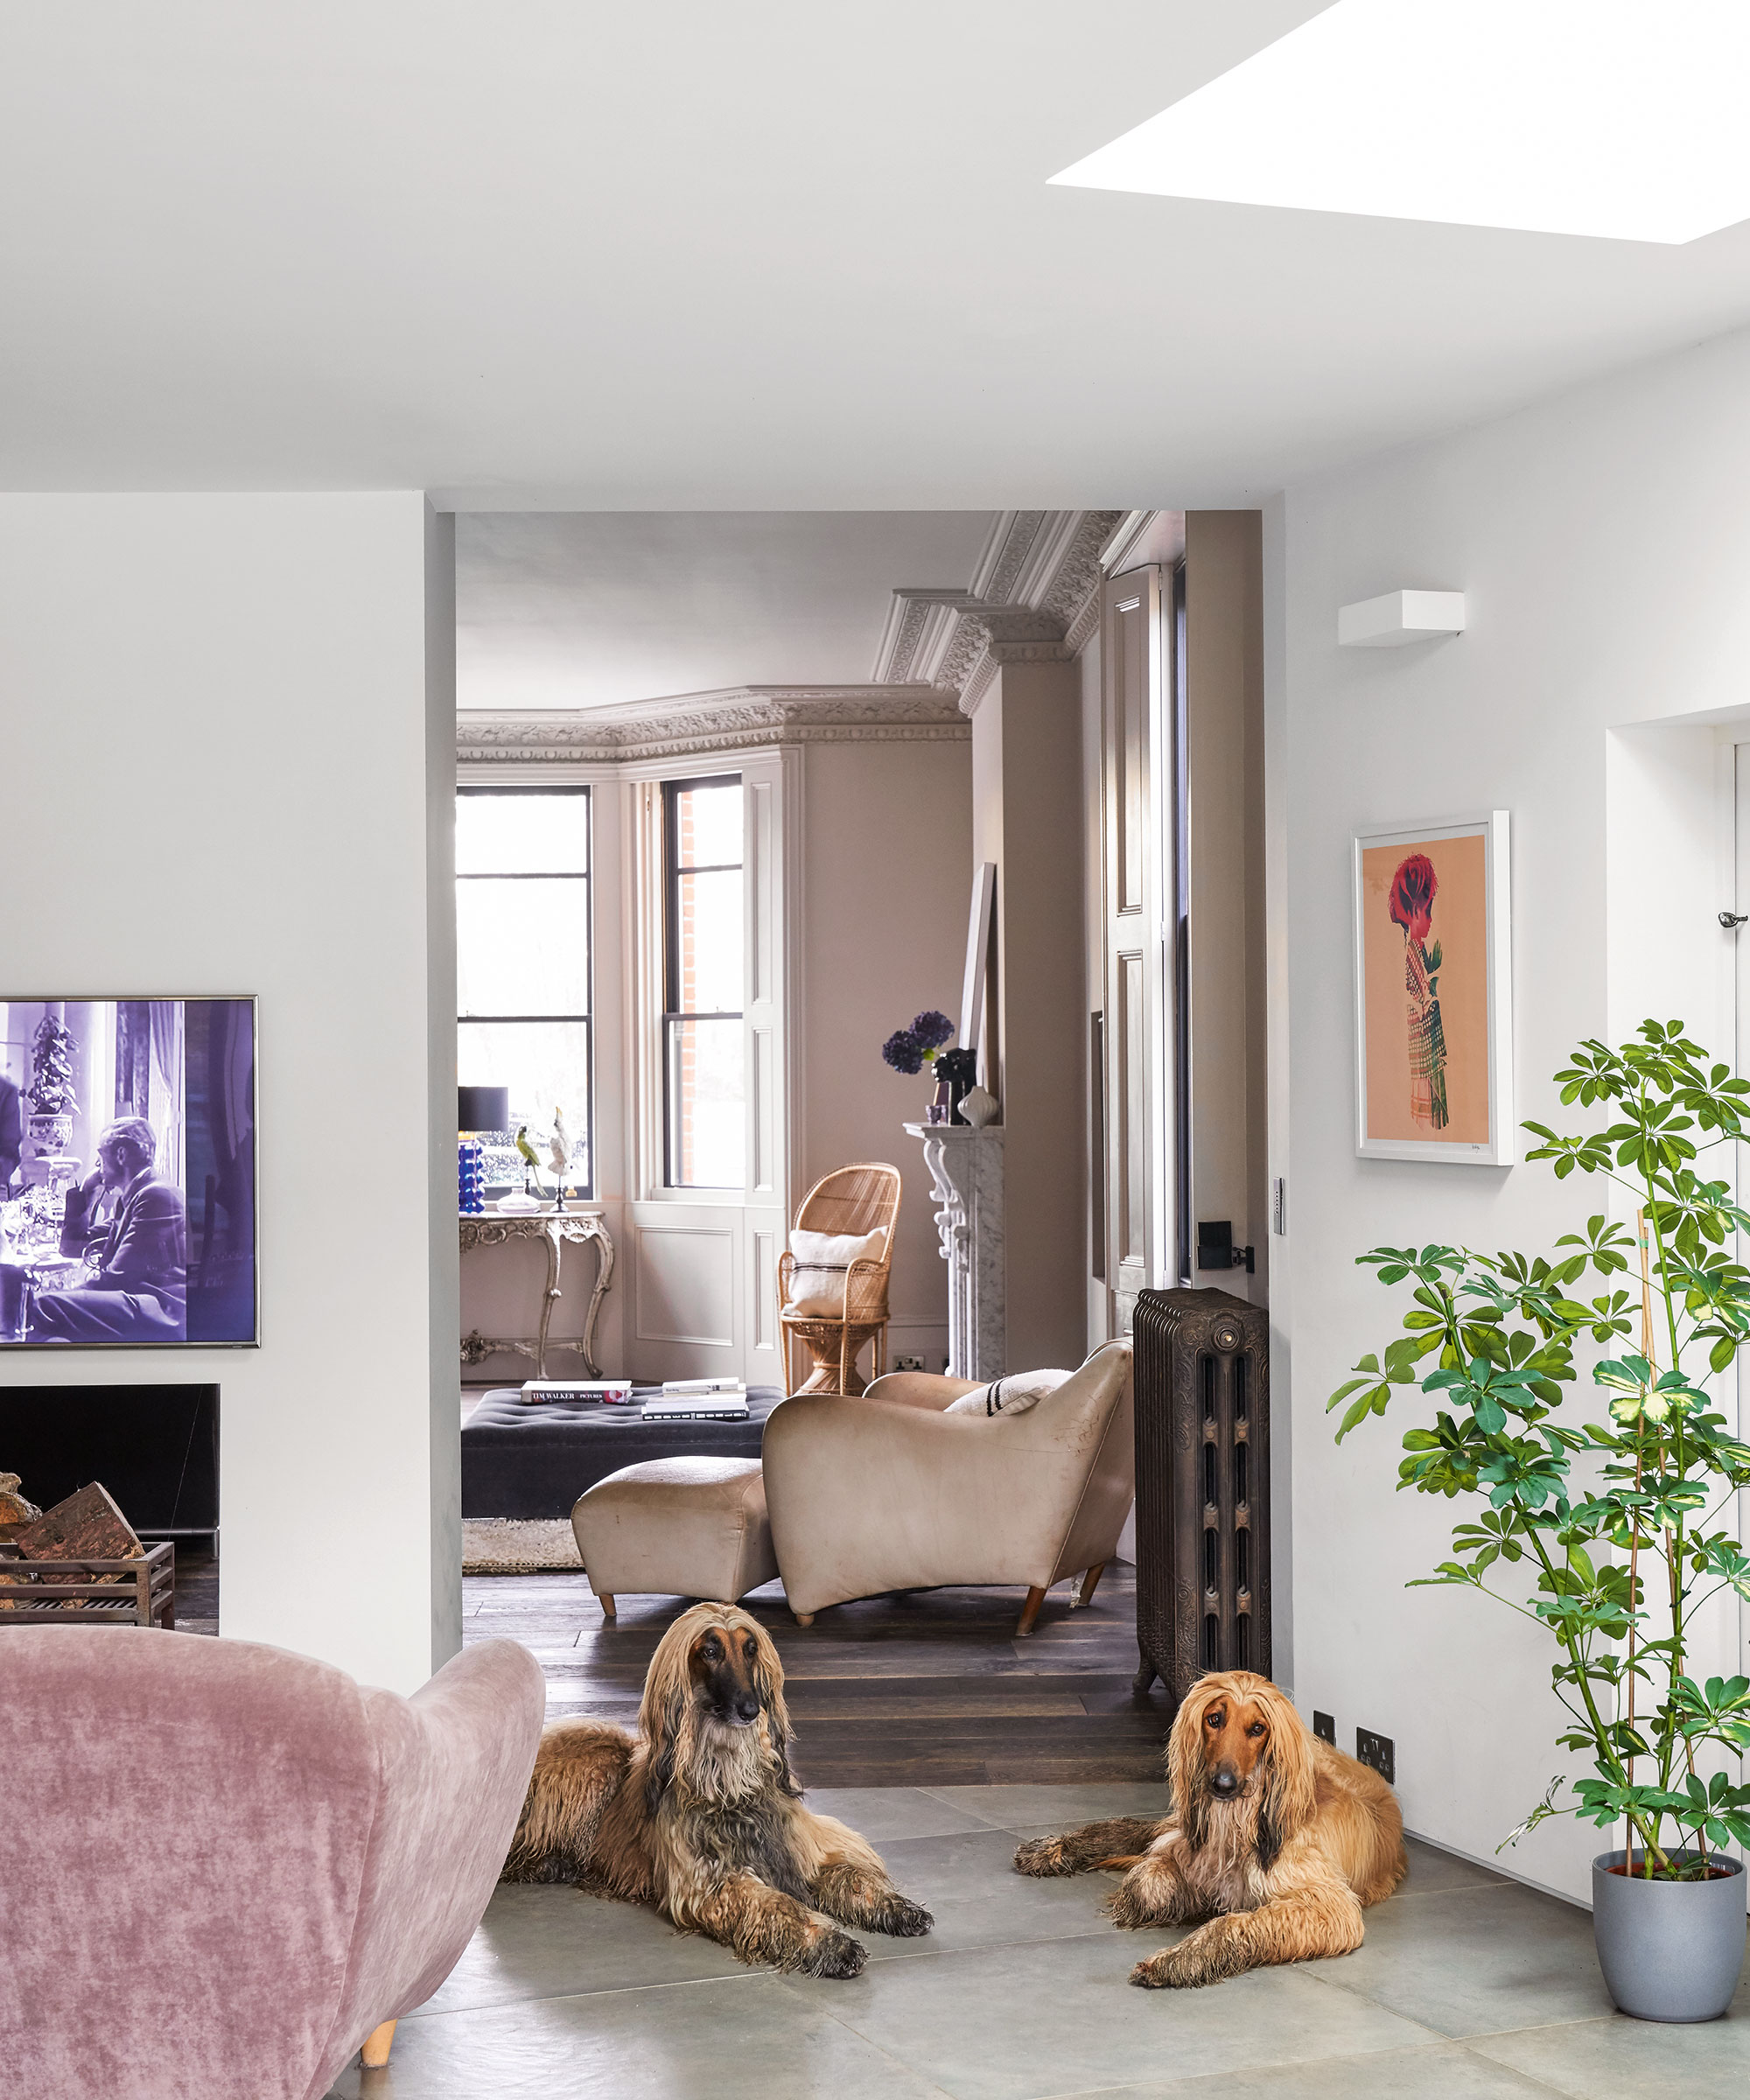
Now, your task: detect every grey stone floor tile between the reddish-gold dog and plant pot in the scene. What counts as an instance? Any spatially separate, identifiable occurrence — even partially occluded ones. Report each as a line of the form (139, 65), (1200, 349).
(1306, 1881), (1612, 2037)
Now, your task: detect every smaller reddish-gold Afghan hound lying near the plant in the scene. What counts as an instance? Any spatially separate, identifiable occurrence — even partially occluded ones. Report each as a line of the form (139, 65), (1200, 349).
(1015, 1670), (1405, 1989)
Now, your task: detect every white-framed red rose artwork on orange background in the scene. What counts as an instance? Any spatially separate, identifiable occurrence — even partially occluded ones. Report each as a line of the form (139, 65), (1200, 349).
(1355, 808), (1516, 1167)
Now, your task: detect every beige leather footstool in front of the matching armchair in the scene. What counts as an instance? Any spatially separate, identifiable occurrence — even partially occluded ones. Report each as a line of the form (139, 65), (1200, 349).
(571, 1458), (777, 1619)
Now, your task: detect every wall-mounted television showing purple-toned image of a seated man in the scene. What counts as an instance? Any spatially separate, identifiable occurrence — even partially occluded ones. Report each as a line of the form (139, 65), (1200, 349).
(0, 999), (258, 1348)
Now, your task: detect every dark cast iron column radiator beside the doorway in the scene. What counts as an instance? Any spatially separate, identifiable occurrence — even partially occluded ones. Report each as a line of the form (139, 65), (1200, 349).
(1132, 1292), (1271, 1705)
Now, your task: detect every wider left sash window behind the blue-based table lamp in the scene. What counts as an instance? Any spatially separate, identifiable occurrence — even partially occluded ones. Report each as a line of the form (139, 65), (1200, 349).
(456, 788), (594, 1195)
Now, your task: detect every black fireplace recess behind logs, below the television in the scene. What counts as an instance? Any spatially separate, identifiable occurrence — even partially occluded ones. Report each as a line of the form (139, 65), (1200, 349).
(0, 1384), (219, 1634)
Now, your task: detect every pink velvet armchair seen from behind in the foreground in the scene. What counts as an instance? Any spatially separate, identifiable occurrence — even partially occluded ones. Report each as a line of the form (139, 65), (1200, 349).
(0, 1626), (544, 2100)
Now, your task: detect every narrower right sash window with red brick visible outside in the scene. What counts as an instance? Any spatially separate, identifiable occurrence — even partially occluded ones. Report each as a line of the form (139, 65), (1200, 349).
(662, 773), (748, 1188)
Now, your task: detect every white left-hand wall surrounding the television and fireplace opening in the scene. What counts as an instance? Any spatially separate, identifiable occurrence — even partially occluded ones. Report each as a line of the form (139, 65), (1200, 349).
(0, 494), (460, 1690)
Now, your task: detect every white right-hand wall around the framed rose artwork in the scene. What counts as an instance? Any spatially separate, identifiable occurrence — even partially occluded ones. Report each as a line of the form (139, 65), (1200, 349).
(1267, 323), (1750, 1896)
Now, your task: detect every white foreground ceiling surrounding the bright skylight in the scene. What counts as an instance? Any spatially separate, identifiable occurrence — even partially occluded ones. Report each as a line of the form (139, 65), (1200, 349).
(0, 0), (1750, 510)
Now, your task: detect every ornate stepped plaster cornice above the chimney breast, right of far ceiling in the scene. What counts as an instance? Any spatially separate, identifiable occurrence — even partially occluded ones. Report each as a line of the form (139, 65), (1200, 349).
(874, 510), (1124, 714)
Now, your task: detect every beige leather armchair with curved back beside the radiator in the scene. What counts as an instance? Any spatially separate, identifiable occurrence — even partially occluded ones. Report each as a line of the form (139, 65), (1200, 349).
(763, 1340), (1137, 1634)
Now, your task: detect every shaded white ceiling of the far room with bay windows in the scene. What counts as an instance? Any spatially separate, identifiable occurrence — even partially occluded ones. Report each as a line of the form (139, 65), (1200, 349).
(456, 510), (996, 708)
